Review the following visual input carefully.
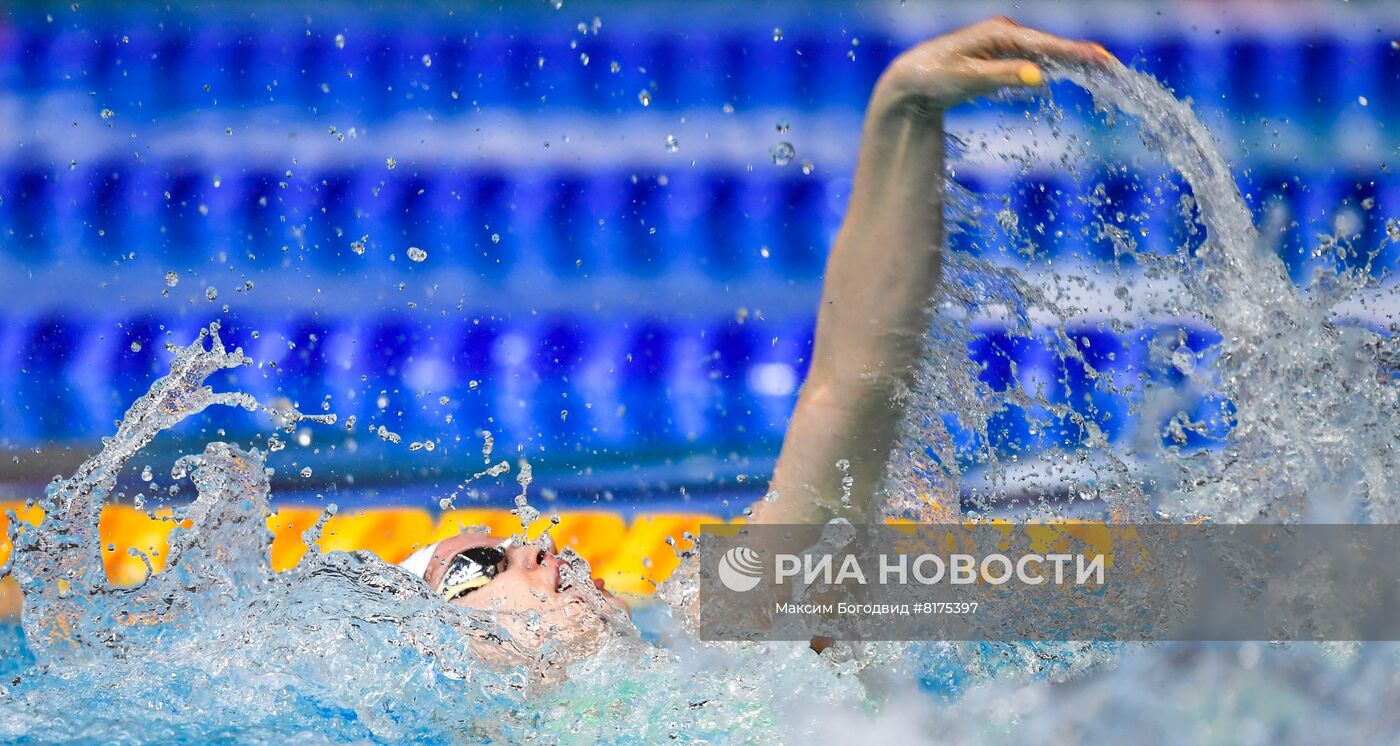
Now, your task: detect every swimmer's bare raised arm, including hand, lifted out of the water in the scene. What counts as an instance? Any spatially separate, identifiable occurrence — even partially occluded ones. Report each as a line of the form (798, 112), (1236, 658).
(752, 18), (1112, 523)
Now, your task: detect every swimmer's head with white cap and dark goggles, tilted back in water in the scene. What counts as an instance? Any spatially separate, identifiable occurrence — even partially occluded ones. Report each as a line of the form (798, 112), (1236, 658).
(400, 532), (630, 663)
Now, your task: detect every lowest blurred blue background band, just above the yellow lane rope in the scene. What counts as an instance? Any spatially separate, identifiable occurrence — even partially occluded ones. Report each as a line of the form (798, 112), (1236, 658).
(0, 307), (1229, 459)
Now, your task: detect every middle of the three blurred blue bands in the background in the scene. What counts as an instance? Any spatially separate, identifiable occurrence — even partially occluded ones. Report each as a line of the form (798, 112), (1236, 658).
(0, 162), (1400, 281)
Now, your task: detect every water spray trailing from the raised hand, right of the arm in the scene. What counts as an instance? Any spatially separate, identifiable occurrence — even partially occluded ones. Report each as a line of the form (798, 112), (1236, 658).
(890, 67), (1400, 522)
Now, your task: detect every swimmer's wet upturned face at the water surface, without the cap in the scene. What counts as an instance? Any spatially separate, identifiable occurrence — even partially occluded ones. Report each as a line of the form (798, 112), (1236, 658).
(423, 532), (630, 652)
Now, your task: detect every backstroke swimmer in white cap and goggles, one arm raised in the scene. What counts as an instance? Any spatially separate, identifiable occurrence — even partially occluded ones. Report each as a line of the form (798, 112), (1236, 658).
(400, 18), (1113, 657)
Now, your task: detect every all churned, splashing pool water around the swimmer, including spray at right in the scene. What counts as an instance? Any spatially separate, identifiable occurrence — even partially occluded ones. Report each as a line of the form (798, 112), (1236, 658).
(0, 61), (1400, 742)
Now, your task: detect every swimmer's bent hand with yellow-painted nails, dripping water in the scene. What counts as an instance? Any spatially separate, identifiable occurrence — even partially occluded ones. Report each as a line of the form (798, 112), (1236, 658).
(871, 17), (1116, 113)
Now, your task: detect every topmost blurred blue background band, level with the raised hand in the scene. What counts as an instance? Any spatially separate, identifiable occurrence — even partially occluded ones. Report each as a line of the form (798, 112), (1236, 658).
(0, 14), (1400, 119)
